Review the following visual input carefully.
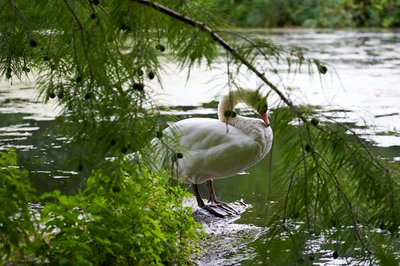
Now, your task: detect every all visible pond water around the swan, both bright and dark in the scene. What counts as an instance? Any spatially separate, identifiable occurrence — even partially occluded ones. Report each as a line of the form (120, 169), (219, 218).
(0, 30), (400, 265)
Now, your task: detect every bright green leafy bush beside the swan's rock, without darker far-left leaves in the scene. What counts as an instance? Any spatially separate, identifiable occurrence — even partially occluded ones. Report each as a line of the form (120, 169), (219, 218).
(37, 161), (197, 265)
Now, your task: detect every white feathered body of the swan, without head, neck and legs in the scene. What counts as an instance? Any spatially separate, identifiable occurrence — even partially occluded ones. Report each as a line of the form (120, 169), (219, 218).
(159, 116), (272, 184)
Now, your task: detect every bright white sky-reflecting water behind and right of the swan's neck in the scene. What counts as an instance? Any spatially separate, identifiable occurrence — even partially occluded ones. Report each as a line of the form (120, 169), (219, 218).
(157, 30), (400, 147)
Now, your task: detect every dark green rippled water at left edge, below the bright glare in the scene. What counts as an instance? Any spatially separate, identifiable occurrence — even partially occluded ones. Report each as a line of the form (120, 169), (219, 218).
(0, 113), (80, 193)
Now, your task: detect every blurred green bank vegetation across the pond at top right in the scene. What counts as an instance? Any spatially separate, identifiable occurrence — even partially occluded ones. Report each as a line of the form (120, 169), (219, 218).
(206, 0), (400, 28)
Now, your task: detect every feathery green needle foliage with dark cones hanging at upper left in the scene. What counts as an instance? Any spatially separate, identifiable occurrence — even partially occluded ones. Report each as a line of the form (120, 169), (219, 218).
(0, 0), (222, 169)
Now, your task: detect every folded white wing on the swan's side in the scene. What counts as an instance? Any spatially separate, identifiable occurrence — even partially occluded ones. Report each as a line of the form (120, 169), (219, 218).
(164, 118), (260, 183)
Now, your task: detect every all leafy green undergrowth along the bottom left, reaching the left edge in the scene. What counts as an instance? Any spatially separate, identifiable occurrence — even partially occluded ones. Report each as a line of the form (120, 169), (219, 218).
(0, 152), (198, 265)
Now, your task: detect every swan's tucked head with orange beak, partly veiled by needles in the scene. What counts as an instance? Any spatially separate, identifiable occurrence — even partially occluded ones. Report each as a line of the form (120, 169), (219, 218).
(240, 89), (270, 127)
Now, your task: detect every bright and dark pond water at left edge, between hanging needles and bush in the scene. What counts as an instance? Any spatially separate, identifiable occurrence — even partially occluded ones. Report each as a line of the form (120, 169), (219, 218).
(0, 82), (81, 193)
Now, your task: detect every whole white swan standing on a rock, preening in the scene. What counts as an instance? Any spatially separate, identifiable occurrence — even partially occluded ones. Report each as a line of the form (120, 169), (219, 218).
(152, 89), (273, 217)
